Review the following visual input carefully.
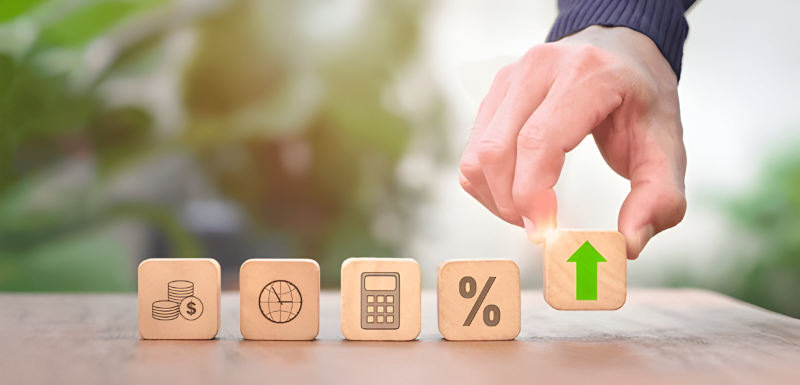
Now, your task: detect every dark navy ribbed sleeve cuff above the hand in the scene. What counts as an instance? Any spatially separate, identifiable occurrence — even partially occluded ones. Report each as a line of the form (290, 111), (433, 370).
(547, 0), (695, 79)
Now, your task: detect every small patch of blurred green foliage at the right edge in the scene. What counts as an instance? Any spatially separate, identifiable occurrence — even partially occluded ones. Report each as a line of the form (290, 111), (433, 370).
(668, 145), (800, 318)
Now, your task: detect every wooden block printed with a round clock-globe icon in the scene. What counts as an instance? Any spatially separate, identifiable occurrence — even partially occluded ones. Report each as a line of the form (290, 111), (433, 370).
(239, 259), (319, 341)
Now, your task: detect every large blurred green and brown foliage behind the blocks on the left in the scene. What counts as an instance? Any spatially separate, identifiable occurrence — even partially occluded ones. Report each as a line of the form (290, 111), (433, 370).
(0, 0), (446, 291)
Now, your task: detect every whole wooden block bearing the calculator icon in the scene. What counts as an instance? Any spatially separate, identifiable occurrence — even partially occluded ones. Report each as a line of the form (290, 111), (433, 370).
(342, 258), (422, 341)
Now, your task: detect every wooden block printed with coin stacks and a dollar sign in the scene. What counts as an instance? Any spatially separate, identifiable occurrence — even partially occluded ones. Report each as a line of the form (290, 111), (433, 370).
(139, 258), (221, 340)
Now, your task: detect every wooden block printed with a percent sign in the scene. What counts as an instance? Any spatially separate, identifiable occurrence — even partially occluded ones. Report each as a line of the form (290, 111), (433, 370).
(437, 260), (521, 341)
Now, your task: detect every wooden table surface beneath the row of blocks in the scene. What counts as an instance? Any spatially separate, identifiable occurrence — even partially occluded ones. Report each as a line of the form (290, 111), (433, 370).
(0, 290), (800, 385)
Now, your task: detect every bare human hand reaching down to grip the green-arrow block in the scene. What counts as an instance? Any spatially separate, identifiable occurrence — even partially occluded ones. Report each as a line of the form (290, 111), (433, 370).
(459, 26), (686, 259)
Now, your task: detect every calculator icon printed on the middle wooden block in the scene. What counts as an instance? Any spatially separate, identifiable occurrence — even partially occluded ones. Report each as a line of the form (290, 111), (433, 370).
(361, 273), (400, 330)
